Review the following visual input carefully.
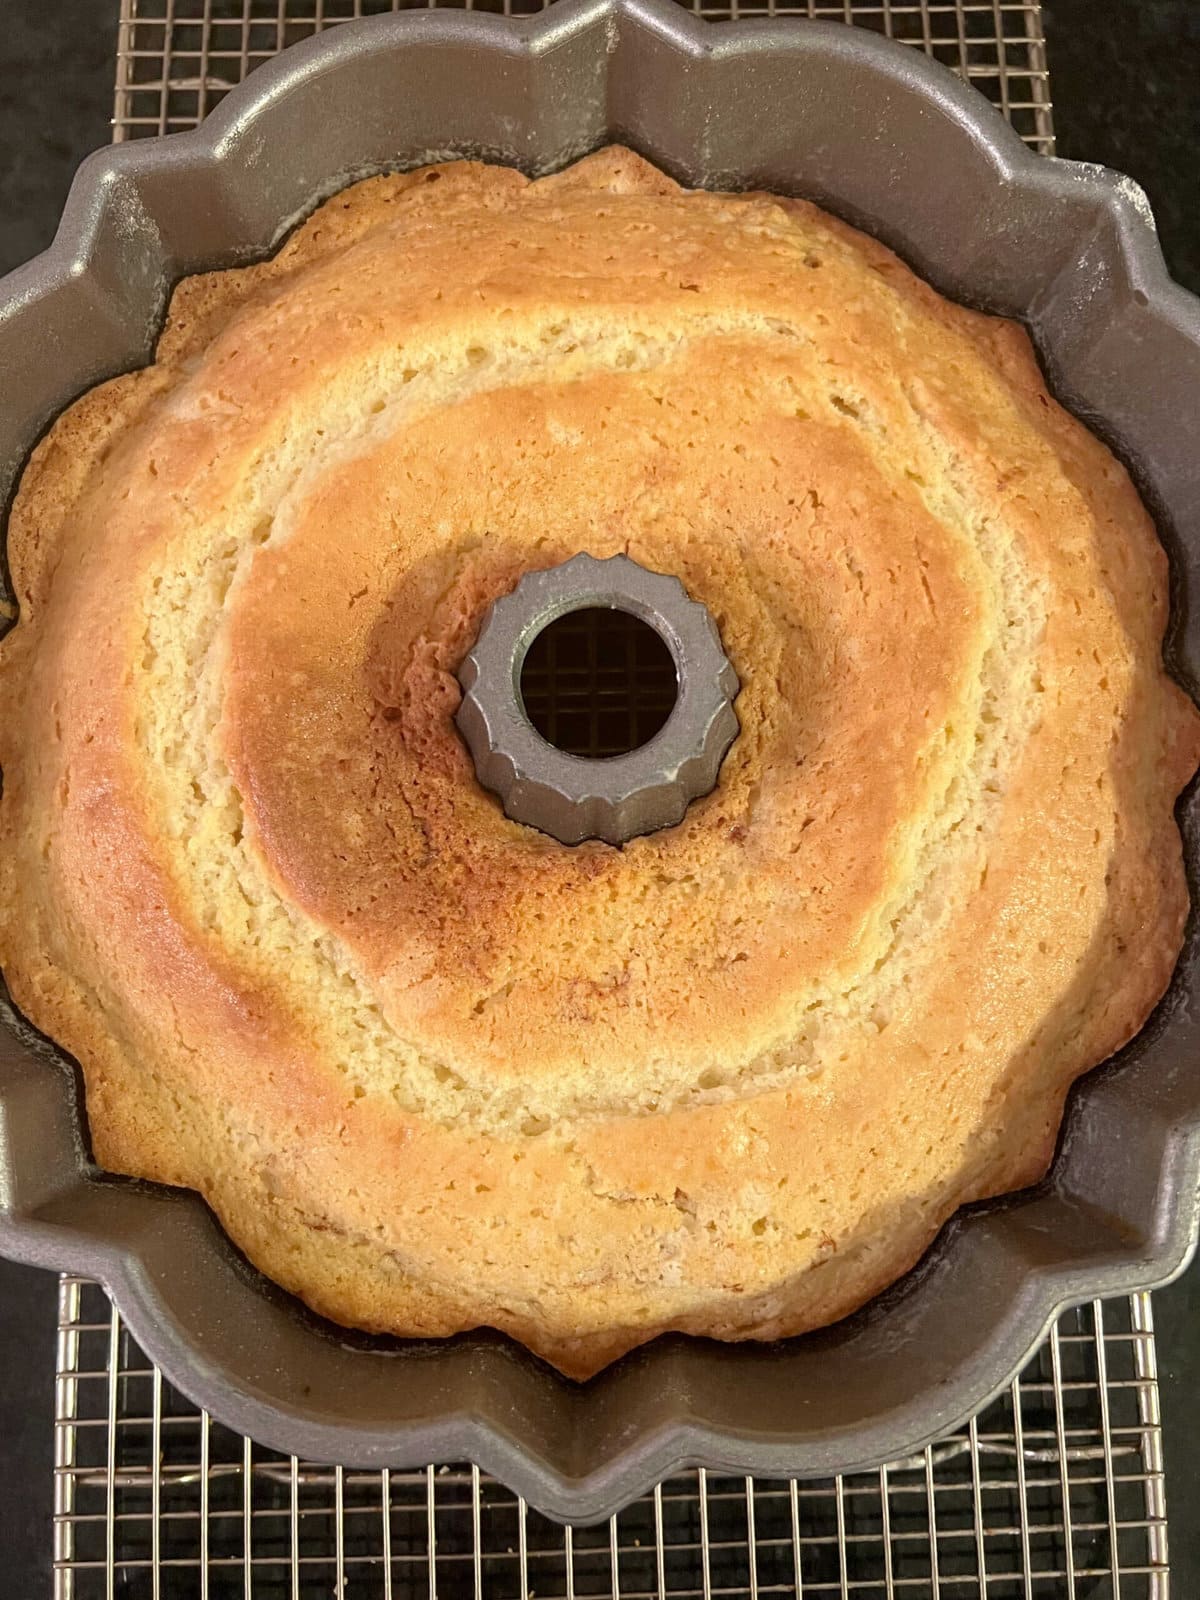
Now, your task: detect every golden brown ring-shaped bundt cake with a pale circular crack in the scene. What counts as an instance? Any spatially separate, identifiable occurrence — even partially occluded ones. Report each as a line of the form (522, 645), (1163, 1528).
(0, 149), (1200, 1376)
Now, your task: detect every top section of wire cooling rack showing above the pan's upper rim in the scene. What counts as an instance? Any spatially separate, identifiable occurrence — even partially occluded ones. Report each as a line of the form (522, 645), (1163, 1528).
(114, 0), (1054, 155)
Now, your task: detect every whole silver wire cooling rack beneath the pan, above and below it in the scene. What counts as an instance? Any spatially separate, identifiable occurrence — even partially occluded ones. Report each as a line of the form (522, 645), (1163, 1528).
(47, 0), (1168, 1600)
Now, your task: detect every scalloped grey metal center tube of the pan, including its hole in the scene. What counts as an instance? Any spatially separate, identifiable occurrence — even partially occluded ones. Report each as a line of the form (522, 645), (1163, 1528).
(454, 555), (739, 845)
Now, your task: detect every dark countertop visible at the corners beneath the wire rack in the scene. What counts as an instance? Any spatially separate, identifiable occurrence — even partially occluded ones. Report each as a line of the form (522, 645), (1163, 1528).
(0, 0), (1200, 1600)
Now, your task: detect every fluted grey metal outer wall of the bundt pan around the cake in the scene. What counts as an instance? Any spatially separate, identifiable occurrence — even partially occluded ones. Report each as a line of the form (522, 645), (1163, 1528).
(0, 0), (1200, 1522)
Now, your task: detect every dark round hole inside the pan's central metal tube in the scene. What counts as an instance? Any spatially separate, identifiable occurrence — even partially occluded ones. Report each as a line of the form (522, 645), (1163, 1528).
(522, 606), (678, 757)
